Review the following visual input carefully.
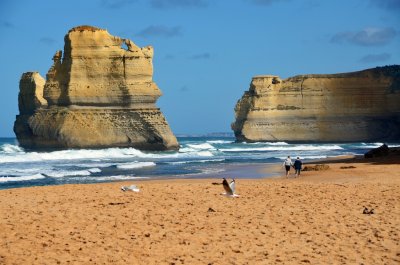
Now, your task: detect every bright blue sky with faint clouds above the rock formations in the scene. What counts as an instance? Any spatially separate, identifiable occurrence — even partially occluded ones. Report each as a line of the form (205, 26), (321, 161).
(0, 0), (400, 137)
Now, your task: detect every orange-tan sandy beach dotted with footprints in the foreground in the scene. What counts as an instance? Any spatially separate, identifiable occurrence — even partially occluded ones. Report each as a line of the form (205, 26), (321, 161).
(0, 156), (400, 264)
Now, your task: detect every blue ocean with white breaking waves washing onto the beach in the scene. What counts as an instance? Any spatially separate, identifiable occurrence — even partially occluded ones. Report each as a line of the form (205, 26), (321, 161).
(0, 137), (396, 189)
